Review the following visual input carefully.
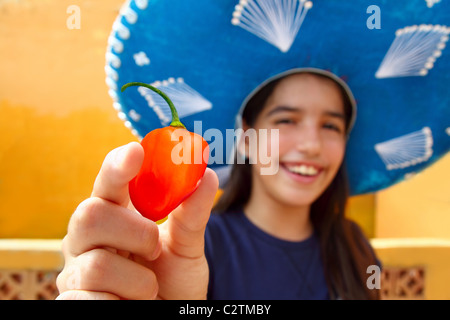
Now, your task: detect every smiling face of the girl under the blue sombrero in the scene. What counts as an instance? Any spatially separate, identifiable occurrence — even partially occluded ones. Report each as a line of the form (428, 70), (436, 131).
(246, 74), (346, 206)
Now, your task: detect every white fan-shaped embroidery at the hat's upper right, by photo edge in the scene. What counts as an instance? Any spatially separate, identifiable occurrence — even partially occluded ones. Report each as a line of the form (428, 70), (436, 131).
(375, 24), (450, 78)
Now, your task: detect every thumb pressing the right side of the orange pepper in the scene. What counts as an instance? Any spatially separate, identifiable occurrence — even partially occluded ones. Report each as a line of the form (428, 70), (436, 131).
(166, 168), (219, 258)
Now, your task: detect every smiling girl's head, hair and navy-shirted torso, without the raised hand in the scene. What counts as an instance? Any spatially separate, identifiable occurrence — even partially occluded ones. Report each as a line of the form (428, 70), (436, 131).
(206, 69), (378, 299)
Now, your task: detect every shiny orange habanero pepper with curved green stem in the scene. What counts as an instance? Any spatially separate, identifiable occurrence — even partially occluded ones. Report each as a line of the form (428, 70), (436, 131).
(122, 82), (209, 221)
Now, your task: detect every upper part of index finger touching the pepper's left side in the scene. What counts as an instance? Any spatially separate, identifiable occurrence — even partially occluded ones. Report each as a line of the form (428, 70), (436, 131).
(92, 142), (144, 207)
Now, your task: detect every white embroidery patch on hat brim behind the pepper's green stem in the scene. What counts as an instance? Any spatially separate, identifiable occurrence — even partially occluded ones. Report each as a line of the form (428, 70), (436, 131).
(138, 78), (212, 126)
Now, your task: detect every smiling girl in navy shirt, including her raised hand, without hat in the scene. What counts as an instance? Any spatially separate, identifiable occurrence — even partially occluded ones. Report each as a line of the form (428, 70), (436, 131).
(57, 69), (378, 299)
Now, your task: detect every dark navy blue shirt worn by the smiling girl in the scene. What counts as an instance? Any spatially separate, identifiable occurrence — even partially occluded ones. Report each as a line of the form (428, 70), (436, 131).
(205, 211), (329, 300)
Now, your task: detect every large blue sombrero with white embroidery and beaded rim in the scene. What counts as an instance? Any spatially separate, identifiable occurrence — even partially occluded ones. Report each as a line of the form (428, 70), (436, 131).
(106, 0), (450, 195)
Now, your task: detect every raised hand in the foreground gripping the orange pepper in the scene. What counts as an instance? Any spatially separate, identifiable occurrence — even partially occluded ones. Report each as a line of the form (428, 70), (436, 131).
(57, 142), (218, 299)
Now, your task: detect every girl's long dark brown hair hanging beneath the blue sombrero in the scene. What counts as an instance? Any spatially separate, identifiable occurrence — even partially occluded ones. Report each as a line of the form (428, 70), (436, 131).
(213, 74), (379, 299)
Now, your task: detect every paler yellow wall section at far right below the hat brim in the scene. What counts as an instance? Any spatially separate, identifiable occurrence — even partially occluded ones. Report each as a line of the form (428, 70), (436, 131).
(375, 153), (450, 239)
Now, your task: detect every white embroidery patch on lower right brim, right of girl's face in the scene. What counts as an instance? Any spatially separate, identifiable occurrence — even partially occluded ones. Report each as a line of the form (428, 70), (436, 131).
(375, 127), (433, 170)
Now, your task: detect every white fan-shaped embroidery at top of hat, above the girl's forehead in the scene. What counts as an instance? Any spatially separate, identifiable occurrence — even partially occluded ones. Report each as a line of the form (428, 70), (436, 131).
(231, 0), (313, 52)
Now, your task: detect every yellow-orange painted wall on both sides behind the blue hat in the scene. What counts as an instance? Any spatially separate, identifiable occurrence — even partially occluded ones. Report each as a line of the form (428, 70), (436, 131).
(0, 0), (450, 238)
